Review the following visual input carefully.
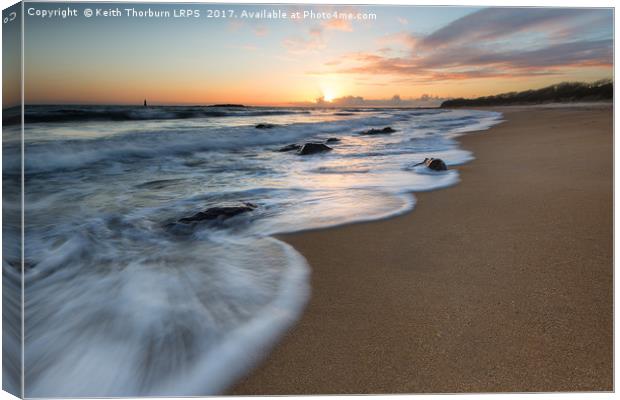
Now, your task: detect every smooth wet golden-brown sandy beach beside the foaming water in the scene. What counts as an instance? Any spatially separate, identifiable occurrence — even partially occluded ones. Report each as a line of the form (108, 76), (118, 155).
(229, 105), (613, 395)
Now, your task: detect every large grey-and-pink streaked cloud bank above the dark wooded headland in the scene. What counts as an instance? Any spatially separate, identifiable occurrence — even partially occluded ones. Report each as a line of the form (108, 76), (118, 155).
(318, 8), (613, 83)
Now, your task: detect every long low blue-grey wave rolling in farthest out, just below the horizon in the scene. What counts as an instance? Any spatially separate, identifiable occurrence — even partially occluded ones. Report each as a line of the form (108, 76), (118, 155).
(15, 111), (432, 173)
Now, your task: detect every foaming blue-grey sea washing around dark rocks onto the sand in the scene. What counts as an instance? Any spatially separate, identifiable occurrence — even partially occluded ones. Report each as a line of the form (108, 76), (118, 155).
(3, 106), (502, 397)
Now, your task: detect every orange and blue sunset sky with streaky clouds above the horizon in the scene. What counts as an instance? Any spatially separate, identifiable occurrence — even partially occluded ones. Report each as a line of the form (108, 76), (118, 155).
(19, 3), (613, 106)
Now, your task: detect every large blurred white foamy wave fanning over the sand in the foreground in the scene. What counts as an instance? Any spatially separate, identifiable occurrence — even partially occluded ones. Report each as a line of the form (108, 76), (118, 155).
(21, 218), (309, 397)
